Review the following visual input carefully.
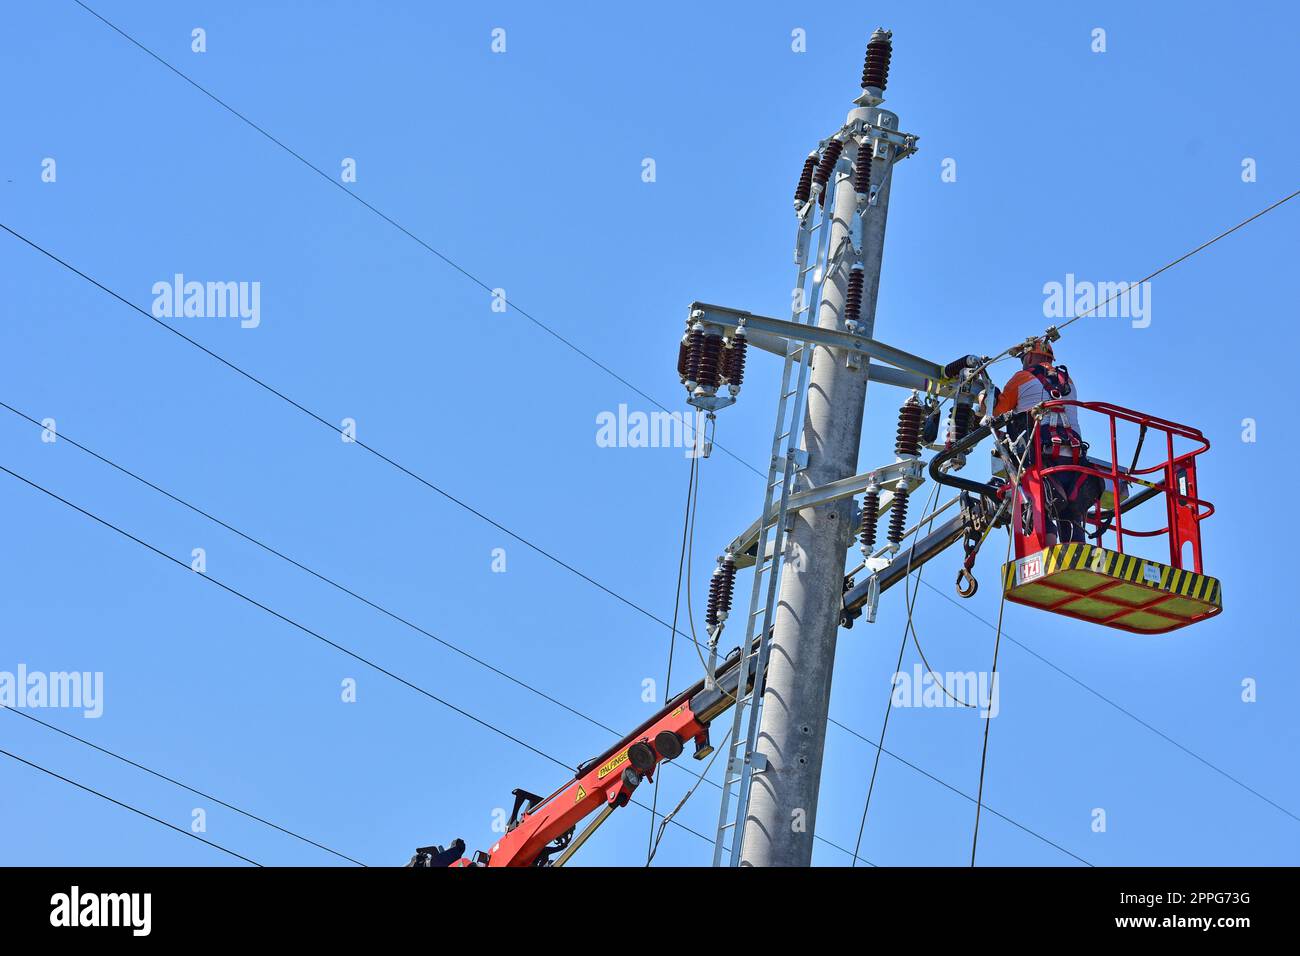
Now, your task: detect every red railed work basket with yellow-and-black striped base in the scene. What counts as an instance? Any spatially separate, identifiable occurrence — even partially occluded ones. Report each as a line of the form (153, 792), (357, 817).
(1002, 401), (1222, 633)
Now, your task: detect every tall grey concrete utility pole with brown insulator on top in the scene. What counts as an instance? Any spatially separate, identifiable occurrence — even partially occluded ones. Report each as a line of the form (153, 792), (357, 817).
(741, 30), (898, 866)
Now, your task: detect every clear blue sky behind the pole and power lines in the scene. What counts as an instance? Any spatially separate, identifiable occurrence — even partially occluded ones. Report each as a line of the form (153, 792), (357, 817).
(0, 0), (1300, 865)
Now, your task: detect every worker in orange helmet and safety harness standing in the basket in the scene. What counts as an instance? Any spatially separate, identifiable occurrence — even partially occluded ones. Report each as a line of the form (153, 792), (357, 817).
(993, 338), (1101, 545)
